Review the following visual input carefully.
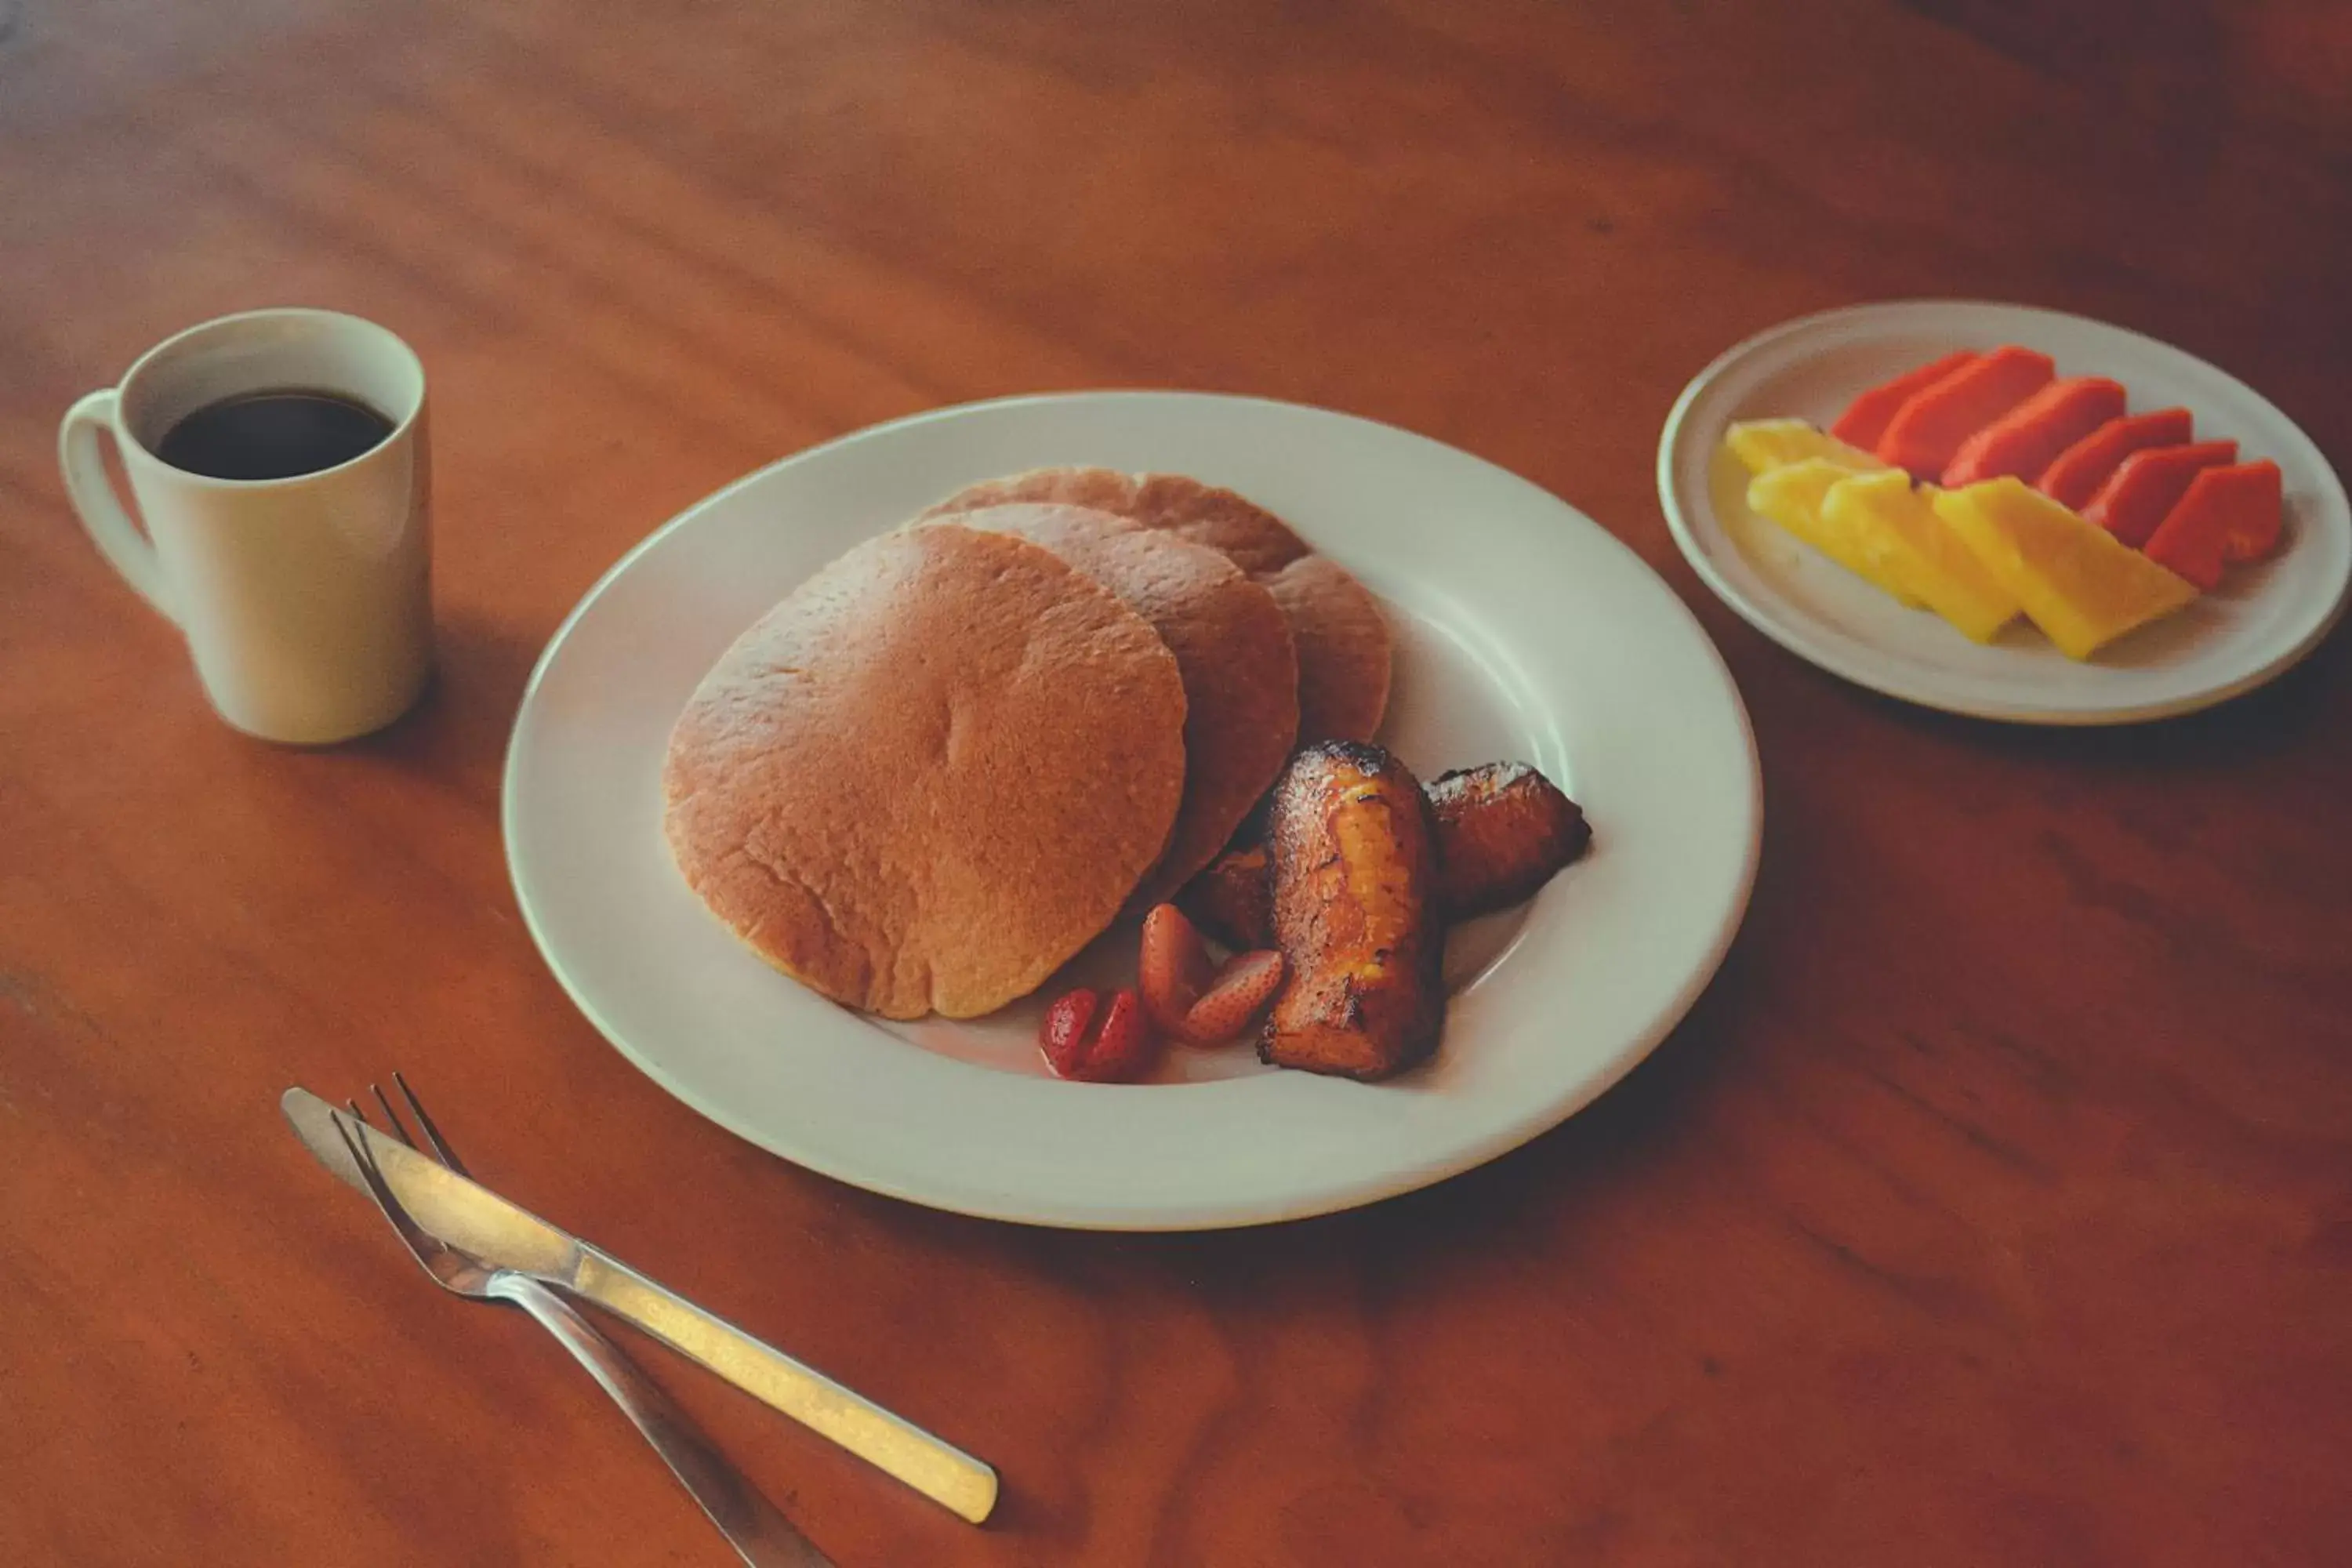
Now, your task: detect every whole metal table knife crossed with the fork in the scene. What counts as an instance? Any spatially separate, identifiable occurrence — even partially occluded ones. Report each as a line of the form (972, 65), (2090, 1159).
(278, 1088), (997, 1523)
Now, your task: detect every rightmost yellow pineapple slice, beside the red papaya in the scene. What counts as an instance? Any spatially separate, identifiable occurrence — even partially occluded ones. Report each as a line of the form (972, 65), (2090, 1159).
(1933, 477), (2197, 659)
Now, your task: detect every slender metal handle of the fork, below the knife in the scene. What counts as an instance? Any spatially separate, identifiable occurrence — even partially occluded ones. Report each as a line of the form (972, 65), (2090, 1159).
(489, 1274), (835, 1568)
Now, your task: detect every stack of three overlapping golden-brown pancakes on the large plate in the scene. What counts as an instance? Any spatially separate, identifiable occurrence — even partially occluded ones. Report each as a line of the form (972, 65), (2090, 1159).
(663, 468), (1390, 1018)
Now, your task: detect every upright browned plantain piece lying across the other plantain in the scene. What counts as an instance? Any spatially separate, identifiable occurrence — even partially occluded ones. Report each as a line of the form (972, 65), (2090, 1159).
(1258, 741), (1446, 1079)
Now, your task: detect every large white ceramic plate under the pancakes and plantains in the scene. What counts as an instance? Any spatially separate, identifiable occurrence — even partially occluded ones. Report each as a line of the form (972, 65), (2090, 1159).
(506, 393), (1762, 1229)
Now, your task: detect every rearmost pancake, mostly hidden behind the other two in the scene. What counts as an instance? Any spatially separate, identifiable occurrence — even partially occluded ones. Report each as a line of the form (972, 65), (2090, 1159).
(922, 468), (1390, 743)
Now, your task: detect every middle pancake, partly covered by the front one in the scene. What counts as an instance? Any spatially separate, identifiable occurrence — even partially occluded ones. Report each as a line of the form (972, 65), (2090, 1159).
(955, 503), (1308, 909)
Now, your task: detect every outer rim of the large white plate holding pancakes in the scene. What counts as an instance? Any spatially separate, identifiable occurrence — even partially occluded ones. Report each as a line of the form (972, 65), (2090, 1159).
(515, 388), (1764, 1232)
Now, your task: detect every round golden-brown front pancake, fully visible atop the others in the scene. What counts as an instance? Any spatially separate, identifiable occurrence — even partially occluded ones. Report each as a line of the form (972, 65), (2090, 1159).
(663, 524), (1185, 1018)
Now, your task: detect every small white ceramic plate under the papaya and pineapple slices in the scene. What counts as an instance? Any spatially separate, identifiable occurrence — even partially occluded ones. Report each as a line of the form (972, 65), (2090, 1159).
(1658, 299), (2352, 724)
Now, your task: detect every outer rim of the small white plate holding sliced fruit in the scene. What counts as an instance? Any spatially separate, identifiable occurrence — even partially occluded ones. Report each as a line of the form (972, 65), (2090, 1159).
(1656, 296), (2352, 729)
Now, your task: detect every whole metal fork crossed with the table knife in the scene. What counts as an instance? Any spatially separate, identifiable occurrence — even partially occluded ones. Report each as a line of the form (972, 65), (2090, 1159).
(334, 1072), (833, 1568)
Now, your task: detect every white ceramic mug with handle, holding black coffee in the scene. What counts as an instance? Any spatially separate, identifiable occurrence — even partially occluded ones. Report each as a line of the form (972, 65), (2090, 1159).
(56, 310), (433, 746)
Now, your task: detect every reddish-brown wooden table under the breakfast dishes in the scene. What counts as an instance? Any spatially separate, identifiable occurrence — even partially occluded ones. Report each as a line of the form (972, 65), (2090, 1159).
(0, 0), (2352, 1568)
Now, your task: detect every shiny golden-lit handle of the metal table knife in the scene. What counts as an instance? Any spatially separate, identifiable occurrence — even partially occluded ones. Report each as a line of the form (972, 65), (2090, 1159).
(579, 1241), (997, 1523)
